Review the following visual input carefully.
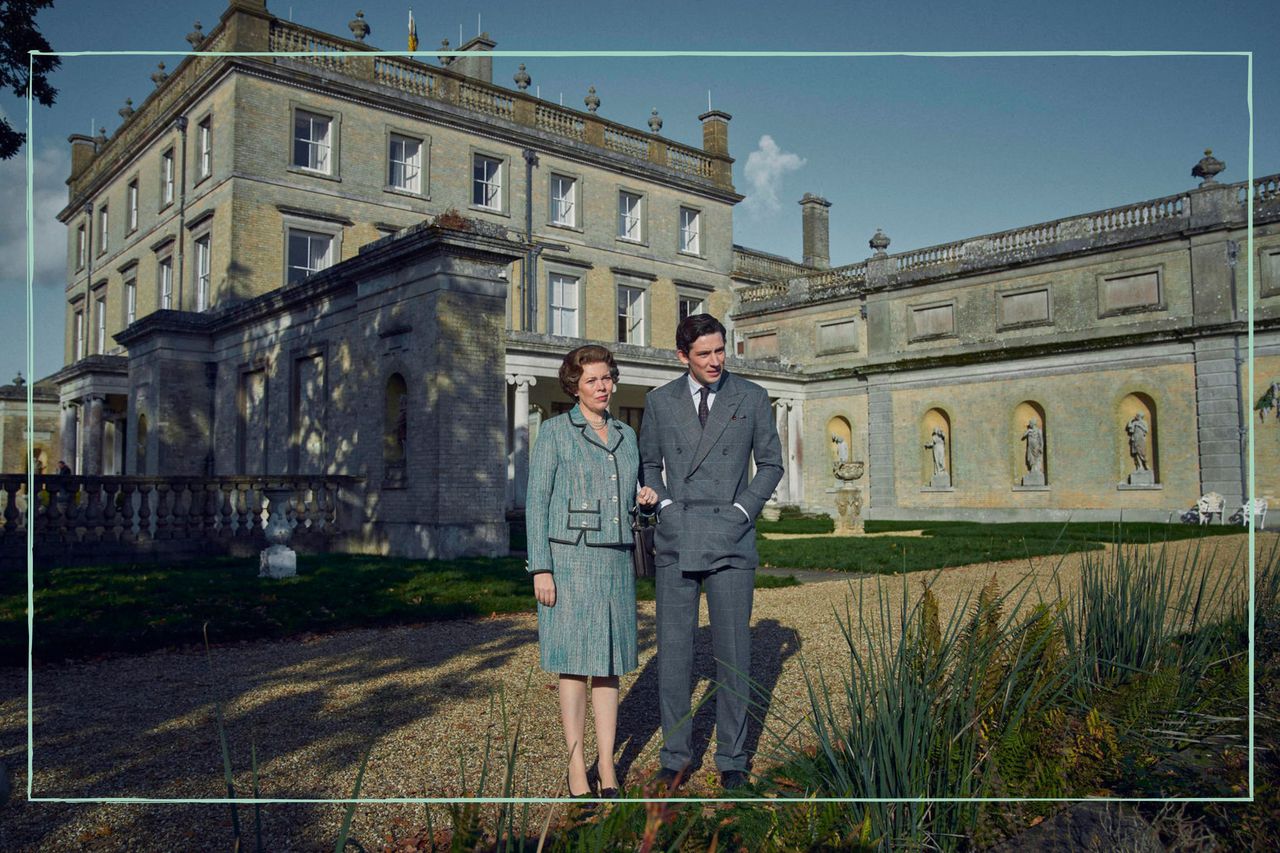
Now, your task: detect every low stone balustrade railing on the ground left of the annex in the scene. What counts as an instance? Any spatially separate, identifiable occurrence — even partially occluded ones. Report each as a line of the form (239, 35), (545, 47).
(0, 474), (360, 553)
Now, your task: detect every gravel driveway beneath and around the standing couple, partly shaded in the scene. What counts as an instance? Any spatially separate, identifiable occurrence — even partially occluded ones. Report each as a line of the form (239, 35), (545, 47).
(0, 534), (1259, 850)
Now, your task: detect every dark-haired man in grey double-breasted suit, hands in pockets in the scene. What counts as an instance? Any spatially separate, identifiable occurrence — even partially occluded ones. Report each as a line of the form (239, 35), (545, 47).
(640, 314), (782, 790)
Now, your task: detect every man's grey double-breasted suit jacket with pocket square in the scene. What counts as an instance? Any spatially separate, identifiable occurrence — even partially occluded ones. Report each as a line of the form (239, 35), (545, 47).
(640, 371), (783, 571)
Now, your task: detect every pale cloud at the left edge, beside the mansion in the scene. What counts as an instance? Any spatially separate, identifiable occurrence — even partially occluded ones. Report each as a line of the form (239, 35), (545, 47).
(0, 145), (70, 292)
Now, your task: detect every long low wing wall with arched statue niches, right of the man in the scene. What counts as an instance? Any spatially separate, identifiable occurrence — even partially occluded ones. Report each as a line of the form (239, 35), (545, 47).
(735, 167), (1280, 520)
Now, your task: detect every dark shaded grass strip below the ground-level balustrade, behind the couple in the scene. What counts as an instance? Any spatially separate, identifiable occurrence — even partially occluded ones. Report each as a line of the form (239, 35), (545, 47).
(0, 555), (795, 665)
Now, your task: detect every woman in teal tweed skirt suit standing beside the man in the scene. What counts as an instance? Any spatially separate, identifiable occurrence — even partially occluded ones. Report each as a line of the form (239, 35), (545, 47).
(525, 346), (658, 797)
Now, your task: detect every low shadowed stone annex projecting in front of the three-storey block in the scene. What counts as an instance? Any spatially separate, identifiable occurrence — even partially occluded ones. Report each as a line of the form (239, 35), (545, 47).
(118, 217), (520, 557)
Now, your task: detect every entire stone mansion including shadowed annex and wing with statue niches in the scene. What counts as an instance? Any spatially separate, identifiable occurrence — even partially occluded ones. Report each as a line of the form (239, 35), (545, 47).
(32, 0), (1280, 556)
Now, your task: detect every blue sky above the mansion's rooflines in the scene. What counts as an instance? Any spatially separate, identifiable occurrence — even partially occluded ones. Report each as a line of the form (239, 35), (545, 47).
(0, 0), (1280, 382)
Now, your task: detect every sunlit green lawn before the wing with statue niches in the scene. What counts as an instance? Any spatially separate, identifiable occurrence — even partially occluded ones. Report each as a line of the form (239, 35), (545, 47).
(756, 521), (1242, 574)
